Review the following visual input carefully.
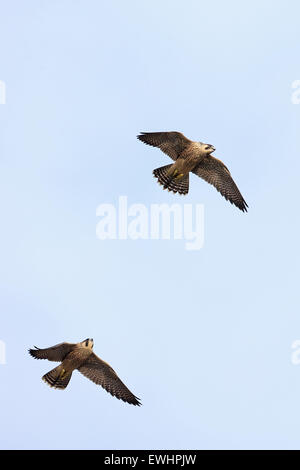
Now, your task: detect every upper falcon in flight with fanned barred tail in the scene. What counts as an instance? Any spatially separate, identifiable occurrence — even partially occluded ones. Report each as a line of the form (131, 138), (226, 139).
(137, 132), (248, 212)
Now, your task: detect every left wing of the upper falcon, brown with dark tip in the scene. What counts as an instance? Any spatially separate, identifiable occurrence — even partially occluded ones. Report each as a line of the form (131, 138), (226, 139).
(137, 132), (191, 160)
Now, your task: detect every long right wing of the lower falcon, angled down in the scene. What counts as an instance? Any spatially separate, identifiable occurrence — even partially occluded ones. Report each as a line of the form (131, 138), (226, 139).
(78, 353), (141, 406)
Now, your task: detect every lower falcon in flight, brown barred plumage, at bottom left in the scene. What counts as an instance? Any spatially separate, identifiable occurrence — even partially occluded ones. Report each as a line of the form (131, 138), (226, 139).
(29, 338), (141, 406)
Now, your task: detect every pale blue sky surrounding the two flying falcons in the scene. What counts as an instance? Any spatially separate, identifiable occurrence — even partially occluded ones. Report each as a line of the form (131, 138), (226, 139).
(0, 0), (300, 449)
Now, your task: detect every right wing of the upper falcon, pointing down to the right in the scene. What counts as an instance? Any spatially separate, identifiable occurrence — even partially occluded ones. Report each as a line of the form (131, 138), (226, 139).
(193, 156), (248, 212)
